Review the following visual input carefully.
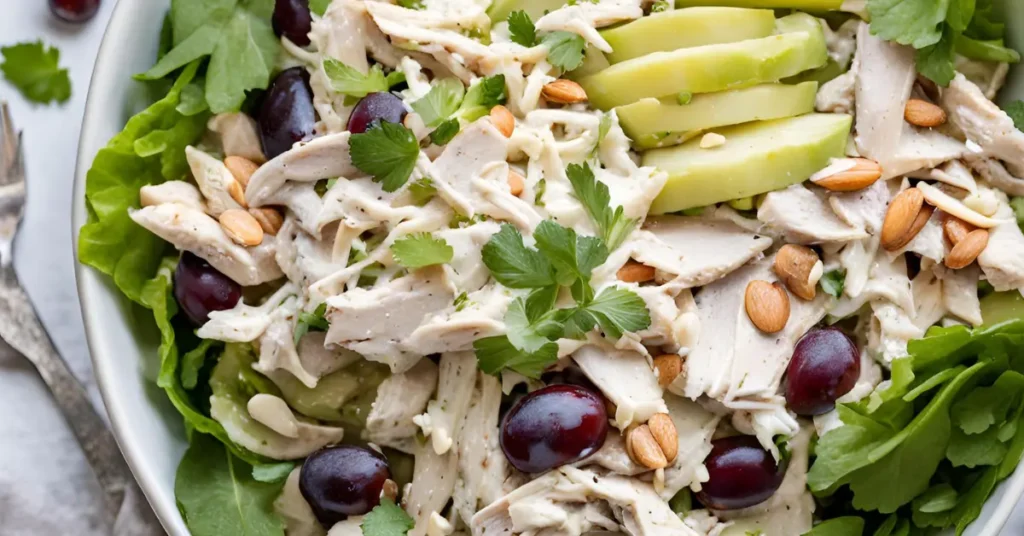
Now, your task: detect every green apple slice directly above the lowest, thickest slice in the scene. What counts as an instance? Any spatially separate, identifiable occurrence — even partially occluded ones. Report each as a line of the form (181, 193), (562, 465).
(615, 82), (818, 147)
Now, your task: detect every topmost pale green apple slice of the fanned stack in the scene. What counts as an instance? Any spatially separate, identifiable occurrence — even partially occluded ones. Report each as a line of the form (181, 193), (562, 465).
(601, 7), (775, 64)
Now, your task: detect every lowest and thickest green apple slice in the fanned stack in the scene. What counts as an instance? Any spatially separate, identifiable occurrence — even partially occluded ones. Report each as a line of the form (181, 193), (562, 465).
(643, 114), (853, 214)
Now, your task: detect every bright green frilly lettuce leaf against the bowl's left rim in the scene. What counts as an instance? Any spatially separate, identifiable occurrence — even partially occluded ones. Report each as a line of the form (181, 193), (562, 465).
(78, 64), (209, 303)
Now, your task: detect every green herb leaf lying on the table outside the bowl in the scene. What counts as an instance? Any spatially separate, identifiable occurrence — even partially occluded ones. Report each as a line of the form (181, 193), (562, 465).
(0, 41), (71, 105)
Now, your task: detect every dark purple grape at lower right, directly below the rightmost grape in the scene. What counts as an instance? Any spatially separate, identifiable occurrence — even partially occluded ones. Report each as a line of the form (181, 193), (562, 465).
(697, 436), (785, 510)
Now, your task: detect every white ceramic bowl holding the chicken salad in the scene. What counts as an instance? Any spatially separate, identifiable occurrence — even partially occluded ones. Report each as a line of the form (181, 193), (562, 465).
(72, 0), (1024, 536)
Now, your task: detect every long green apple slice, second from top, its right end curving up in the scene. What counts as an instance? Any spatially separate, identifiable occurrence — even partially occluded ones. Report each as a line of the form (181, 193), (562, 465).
(580, 13), (828, 110)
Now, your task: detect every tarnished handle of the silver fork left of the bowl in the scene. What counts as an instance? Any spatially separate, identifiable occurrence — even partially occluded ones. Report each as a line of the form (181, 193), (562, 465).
(0, 264), (155, 524)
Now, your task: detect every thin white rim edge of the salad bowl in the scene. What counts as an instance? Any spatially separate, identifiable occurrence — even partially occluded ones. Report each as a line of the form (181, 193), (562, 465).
(72, 0), (1024, 536)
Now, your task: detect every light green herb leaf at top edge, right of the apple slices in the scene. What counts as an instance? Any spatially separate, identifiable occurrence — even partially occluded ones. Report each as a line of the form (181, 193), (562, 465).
(867, 0), (946, 49)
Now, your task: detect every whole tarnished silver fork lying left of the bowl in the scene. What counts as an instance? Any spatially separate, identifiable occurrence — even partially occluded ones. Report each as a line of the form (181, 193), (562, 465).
(0, 101), (164, 536)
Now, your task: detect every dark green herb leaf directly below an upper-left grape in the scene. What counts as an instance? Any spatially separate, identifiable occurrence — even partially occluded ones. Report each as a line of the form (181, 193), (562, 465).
(348, 121), (420, 192)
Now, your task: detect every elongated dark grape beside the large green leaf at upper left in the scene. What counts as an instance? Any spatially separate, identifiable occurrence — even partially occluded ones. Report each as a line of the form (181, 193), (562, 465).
(256, 67), (316, 159)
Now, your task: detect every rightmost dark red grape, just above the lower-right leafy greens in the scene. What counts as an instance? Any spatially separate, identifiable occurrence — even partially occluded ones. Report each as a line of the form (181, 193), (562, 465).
(785, 328), (860, 415)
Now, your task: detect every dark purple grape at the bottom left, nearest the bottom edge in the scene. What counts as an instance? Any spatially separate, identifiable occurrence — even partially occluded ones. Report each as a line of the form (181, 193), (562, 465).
(299, 445), (391, 528)
